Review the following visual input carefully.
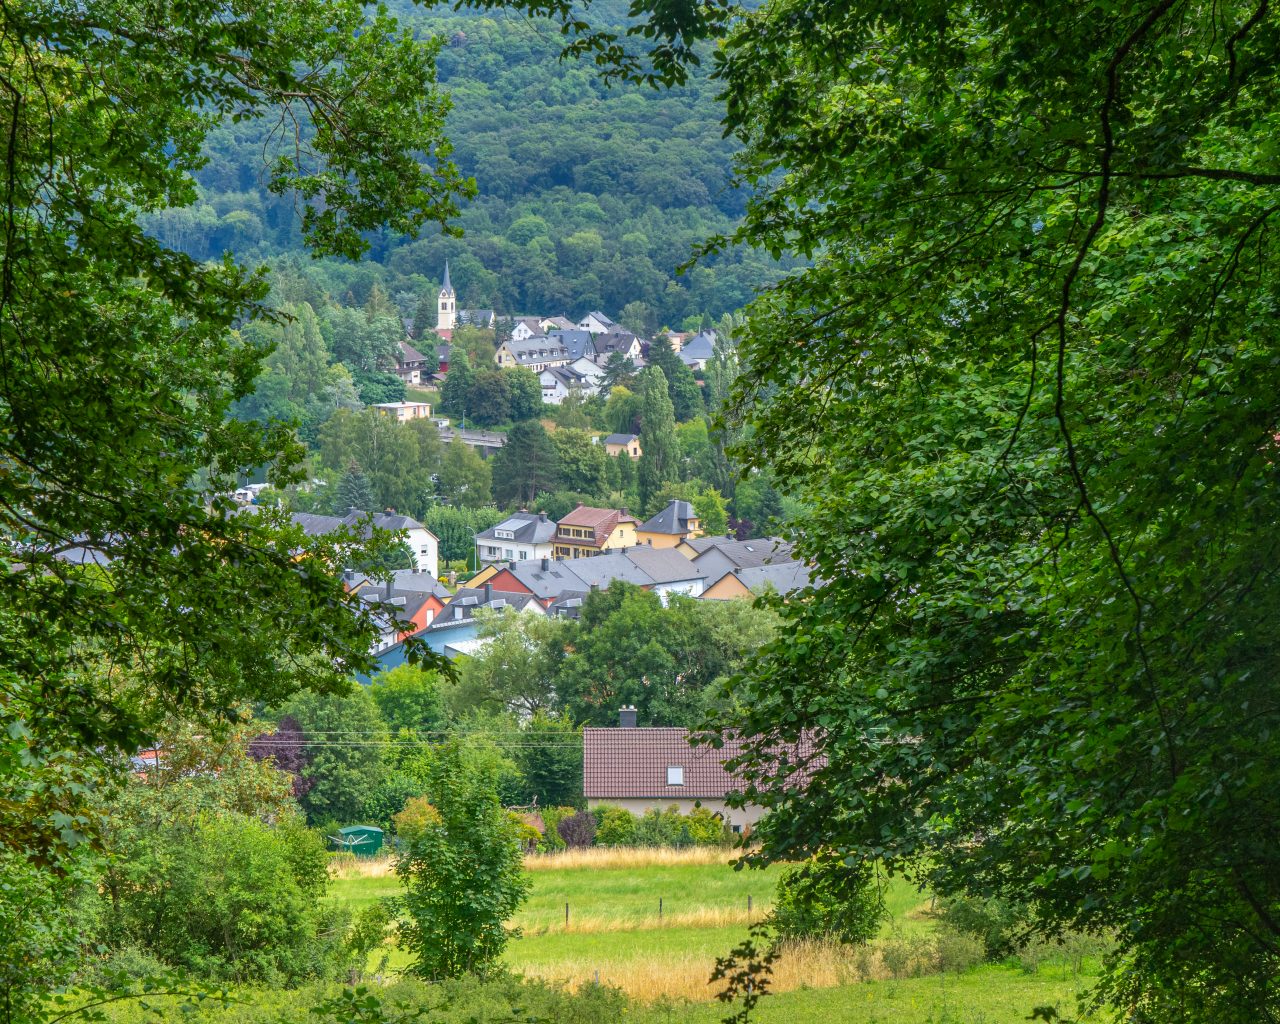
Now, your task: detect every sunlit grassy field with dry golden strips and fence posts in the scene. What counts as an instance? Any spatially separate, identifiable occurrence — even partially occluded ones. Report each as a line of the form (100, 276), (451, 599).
(333, 850), (1093, 1024)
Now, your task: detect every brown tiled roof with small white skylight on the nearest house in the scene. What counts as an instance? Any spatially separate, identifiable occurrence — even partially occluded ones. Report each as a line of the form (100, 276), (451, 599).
(582, 727), (809, 800)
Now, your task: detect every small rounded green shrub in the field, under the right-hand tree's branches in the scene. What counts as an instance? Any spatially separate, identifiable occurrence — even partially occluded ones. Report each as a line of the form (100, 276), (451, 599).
(773, 855), (884, 943)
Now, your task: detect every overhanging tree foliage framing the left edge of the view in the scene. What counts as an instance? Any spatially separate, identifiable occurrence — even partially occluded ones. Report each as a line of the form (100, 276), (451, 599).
(0, 10), (470, 1018)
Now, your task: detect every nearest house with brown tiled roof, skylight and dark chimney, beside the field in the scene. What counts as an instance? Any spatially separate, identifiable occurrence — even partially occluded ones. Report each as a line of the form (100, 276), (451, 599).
(582, 707), (813, 832)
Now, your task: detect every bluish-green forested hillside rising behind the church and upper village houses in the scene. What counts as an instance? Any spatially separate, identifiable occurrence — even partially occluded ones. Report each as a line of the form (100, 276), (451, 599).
(137, 0), (780, 329)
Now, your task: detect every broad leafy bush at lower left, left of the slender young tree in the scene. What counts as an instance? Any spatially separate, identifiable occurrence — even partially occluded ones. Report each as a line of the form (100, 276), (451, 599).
(92, 728), (344, 983)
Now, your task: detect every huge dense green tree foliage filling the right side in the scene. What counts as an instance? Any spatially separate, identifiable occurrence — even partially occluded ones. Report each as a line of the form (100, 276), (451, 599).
(675, 3), (1280, 1024)
